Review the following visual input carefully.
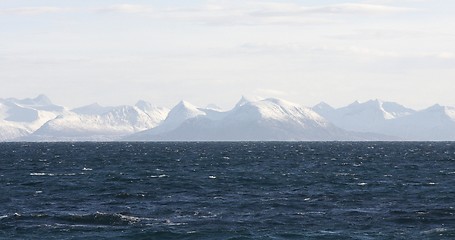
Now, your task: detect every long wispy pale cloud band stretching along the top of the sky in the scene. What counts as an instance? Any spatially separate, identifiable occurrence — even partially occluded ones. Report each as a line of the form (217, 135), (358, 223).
(93, 1), (416, 25)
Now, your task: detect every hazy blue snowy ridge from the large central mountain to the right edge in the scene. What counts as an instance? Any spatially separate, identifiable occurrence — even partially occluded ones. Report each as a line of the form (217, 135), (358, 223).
(313, 100), (455, 141)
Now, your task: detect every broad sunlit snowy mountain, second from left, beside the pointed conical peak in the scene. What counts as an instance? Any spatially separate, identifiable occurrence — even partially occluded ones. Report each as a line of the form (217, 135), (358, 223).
(26, 101), (168, 141)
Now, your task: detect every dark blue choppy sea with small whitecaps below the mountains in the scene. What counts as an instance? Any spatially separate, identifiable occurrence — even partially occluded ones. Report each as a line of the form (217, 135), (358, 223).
(0, 142), (455, 239)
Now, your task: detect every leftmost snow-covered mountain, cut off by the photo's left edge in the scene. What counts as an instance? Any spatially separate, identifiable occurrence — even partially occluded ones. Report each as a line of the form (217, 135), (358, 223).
(0, 95), (67, 141)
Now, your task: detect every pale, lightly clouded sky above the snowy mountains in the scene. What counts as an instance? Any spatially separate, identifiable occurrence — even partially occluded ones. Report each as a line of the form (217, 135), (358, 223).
(0, 0), (455, 109)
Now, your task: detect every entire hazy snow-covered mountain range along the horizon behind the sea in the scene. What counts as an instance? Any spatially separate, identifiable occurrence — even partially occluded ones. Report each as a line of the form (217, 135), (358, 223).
(0, 95), (455, 141)
